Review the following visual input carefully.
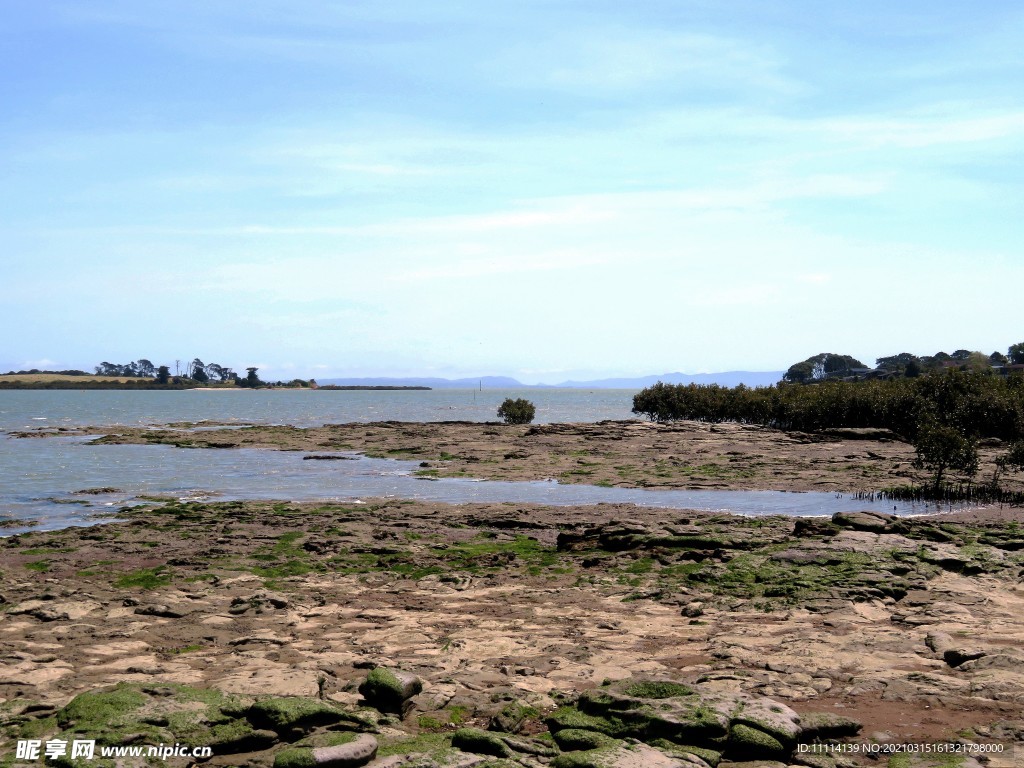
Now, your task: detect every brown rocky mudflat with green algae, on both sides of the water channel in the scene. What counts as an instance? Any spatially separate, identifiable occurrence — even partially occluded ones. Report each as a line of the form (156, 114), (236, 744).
(0, 422), (1024, 768)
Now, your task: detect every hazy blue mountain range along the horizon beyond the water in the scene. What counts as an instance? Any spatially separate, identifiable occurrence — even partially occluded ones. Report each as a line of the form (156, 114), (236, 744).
(317, 371), (784, 389)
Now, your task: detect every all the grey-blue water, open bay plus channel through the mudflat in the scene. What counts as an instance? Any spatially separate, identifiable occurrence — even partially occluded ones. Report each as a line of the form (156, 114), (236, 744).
(0, 389), (966, 534)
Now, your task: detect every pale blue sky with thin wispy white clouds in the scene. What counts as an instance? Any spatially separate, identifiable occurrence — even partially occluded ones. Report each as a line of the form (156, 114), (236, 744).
(0, 0), (1024, 383)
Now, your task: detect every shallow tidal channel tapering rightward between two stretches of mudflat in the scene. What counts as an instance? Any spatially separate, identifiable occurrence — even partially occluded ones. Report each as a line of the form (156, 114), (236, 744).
(0, 437), (958, 534)
